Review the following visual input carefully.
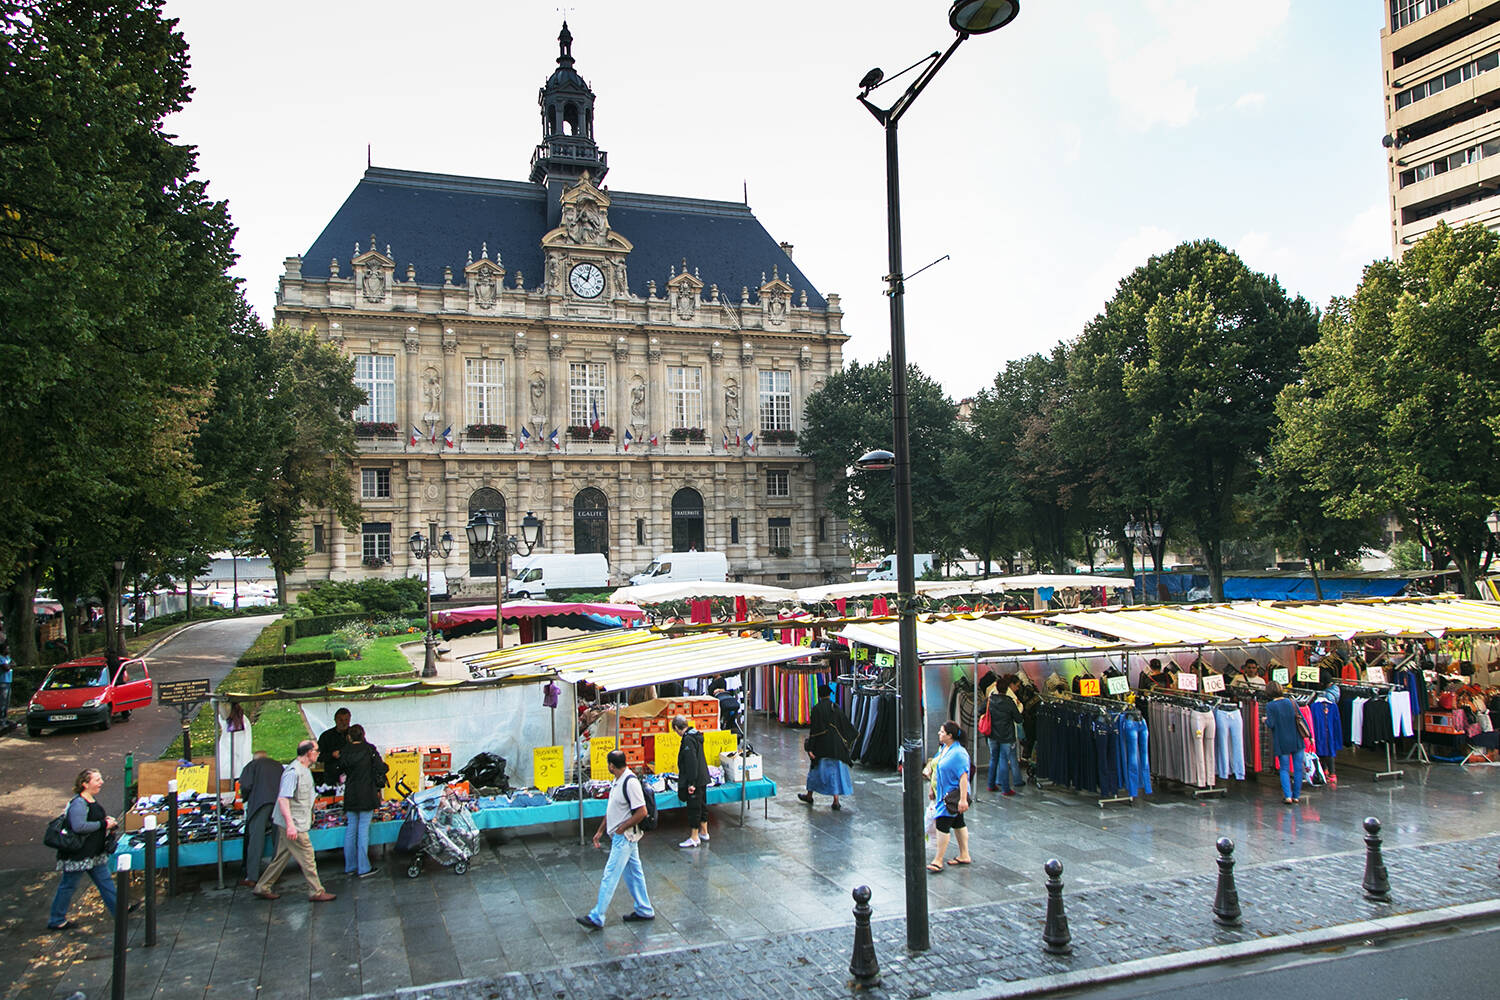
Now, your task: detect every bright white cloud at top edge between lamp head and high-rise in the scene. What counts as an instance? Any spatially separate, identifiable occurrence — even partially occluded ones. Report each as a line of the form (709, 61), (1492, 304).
(1091, 0), (1292, 132)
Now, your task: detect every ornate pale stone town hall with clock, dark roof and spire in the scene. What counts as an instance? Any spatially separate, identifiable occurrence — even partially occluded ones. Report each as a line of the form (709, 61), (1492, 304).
(276, 24), (849, 595)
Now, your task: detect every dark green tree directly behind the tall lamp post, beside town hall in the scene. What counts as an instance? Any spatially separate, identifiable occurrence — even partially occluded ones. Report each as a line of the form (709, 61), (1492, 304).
(798, 357), (959, 553)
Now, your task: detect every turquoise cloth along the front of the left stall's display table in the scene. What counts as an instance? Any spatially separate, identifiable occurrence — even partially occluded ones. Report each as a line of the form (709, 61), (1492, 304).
(116, 778), (776, 870)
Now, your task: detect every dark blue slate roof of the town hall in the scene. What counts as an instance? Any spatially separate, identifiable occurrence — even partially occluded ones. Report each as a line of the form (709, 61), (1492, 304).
(302, 166), (828, 309)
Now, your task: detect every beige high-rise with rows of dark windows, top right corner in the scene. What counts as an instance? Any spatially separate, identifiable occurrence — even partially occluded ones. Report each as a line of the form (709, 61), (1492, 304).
(1380, 0), (1500, 256)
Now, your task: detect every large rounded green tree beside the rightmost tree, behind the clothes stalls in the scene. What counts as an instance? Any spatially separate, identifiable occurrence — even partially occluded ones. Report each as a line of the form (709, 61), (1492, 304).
(1071, 240), (1317, 600)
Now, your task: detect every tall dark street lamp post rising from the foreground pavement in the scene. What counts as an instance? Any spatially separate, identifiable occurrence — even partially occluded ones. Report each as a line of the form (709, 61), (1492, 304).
(858, 0), (1020, 951)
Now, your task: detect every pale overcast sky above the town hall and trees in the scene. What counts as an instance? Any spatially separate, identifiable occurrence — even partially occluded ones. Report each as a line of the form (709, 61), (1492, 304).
(158, 0), (1391, 397)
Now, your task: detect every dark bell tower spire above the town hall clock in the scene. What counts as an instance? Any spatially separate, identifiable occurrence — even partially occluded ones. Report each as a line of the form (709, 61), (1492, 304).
(531, 21), (609, 226)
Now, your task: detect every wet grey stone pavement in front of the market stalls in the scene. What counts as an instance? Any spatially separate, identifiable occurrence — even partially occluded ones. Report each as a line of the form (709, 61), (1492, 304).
(0, 695), (1500, 1000)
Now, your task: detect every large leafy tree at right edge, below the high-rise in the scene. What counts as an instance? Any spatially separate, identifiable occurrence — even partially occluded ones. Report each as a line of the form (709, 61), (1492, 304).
(1277, 223), (1500, 594)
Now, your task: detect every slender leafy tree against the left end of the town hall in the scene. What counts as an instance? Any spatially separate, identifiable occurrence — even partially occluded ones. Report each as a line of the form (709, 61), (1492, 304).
(245, 324), (365, 604)
